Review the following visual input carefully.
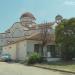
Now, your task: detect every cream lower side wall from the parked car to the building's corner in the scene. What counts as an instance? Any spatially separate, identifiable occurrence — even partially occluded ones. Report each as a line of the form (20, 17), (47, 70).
(2, 41), (26, 60)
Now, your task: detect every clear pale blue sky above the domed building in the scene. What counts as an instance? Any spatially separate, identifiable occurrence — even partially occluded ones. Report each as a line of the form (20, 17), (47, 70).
(0, 0), (75, 33)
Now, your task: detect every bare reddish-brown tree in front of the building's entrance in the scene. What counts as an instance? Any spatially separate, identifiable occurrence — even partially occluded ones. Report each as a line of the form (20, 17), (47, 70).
(40, 23), (51, 55)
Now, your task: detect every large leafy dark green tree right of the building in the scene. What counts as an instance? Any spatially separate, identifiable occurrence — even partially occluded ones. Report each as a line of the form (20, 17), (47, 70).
(56, 18), (75, 60)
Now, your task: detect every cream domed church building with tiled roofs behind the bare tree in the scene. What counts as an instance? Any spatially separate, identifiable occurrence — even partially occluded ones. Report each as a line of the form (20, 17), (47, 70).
(0, 12), (58, 61)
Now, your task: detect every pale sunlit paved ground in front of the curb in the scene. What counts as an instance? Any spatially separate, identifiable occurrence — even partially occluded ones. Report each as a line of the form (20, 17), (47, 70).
(0, 62), (73, 75)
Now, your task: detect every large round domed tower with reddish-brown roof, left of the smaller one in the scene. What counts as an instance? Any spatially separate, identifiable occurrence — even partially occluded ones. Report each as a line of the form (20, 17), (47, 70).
(20, 12), (36, 27)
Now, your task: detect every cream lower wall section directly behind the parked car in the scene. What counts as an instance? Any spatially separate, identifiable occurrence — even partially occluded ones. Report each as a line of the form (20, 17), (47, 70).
(2, 44), (16, 60)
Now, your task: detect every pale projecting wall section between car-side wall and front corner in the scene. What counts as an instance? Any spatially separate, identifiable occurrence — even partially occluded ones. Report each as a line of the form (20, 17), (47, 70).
(16, 41), (27, 60)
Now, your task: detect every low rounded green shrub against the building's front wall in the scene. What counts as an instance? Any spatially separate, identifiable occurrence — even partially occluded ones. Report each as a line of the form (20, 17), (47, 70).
(27, 53), (42, 64)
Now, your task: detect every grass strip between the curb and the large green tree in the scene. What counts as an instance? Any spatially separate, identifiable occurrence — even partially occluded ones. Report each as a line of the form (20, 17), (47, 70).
(35, 61), (75, 72)
